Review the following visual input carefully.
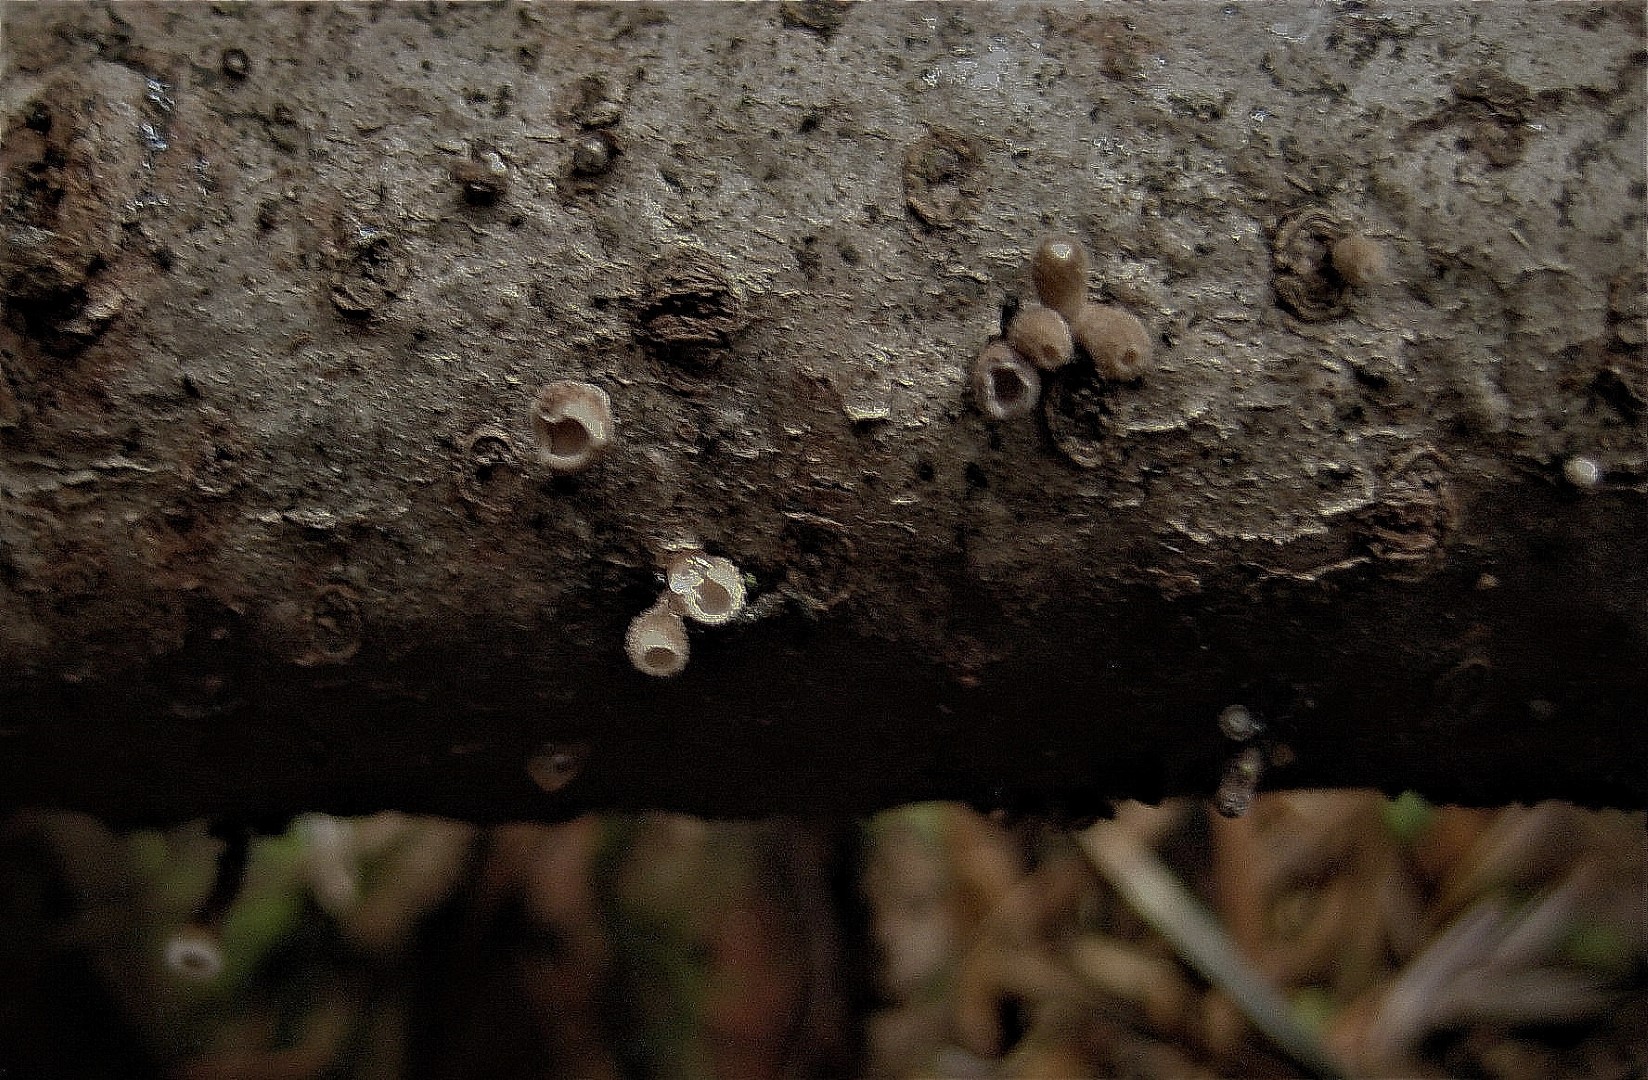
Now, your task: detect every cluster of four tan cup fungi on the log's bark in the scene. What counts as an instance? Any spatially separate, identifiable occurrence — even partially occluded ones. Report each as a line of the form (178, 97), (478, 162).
(972, 236), (1152, 420)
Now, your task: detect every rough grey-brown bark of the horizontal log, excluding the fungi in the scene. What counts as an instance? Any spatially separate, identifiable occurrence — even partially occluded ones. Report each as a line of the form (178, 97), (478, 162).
(0, 3), (1648, 823)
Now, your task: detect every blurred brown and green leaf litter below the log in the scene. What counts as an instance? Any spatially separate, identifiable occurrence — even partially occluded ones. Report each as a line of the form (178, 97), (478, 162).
(0, 793), (1648, 1080)
